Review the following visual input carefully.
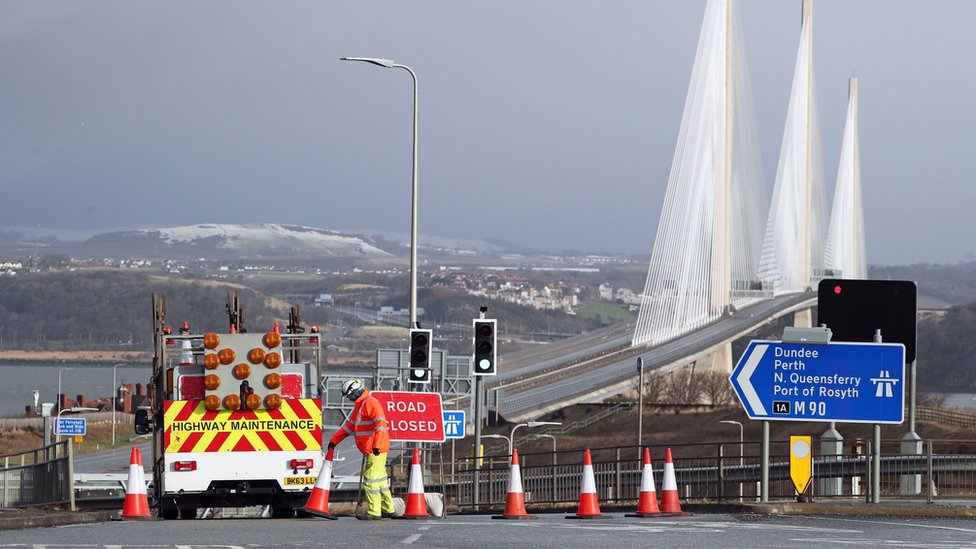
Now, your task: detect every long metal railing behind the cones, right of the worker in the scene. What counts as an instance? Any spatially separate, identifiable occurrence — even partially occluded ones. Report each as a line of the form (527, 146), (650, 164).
(422, 440), (976, 510)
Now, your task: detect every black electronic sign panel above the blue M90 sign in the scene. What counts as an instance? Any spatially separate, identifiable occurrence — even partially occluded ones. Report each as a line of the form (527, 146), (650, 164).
(817, 278), (918, 362)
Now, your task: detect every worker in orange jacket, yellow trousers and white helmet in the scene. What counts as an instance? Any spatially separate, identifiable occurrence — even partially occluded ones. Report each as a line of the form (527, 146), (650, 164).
(329, 379), (393, 520)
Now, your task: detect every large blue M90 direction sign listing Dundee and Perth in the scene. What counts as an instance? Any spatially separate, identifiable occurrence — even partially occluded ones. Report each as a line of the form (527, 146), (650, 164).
(729, 341), (905, 424)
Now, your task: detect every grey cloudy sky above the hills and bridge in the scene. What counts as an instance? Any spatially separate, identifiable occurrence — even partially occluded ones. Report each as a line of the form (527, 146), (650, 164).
(0, 0), (976, 265)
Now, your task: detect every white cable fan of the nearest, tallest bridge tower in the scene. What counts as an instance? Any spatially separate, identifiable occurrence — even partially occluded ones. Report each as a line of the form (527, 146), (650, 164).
(633, 0), (766, 345)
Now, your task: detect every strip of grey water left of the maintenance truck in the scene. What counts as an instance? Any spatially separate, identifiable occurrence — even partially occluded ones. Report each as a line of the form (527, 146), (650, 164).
(0, 363), (152, 417)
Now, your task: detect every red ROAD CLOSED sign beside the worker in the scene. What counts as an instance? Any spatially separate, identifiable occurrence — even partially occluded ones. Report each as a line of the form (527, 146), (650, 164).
(372, 391), (444, 442)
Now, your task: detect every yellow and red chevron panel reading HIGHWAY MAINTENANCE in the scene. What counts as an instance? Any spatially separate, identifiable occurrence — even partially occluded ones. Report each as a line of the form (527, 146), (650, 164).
(163, 399), (322, 452)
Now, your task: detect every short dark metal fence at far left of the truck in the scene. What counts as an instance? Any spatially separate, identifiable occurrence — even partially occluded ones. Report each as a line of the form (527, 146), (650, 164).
(0, 440), (74, 509)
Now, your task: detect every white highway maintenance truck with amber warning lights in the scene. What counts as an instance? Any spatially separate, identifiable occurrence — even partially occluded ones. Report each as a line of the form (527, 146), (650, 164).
(135, 292), (323, 519)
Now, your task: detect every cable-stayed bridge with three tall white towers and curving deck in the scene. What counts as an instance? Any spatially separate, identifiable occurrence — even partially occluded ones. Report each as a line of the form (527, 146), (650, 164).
(488, 0), (867, 421)
